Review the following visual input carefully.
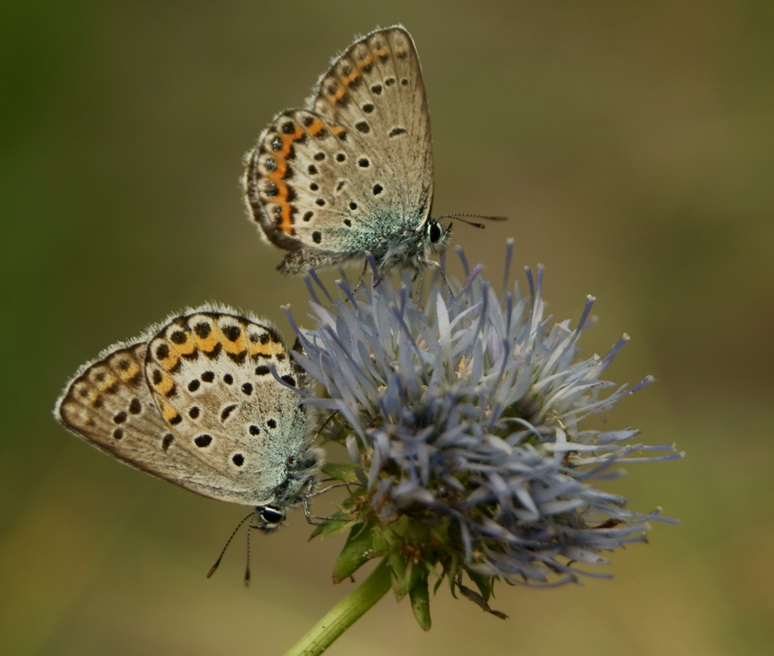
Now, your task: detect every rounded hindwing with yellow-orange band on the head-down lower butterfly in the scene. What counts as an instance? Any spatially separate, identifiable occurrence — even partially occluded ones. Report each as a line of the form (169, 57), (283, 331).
(146, 312), (306, 505)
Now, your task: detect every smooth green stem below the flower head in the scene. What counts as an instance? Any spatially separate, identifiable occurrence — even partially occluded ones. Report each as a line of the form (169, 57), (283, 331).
(284, 559), (390, 656)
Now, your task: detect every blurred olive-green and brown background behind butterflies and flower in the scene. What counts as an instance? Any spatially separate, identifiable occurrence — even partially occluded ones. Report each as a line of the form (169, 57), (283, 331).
(0, 0), (774, 656)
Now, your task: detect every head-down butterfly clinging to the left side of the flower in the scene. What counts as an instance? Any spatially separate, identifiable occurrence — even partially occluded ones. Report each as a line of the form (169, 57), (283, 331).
(55, 305), (323, 528)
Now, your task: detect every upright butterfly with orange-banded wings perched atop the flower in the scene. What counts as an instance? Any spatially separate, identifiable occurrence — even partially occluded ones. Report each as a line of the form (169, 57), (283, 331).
(244, 26), (449, 274)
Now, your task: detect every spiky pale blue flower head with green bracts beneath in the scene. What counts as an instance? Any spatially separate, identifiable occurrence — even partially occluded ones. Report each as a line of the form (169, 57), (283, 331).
(294, 242), (679, 626)
